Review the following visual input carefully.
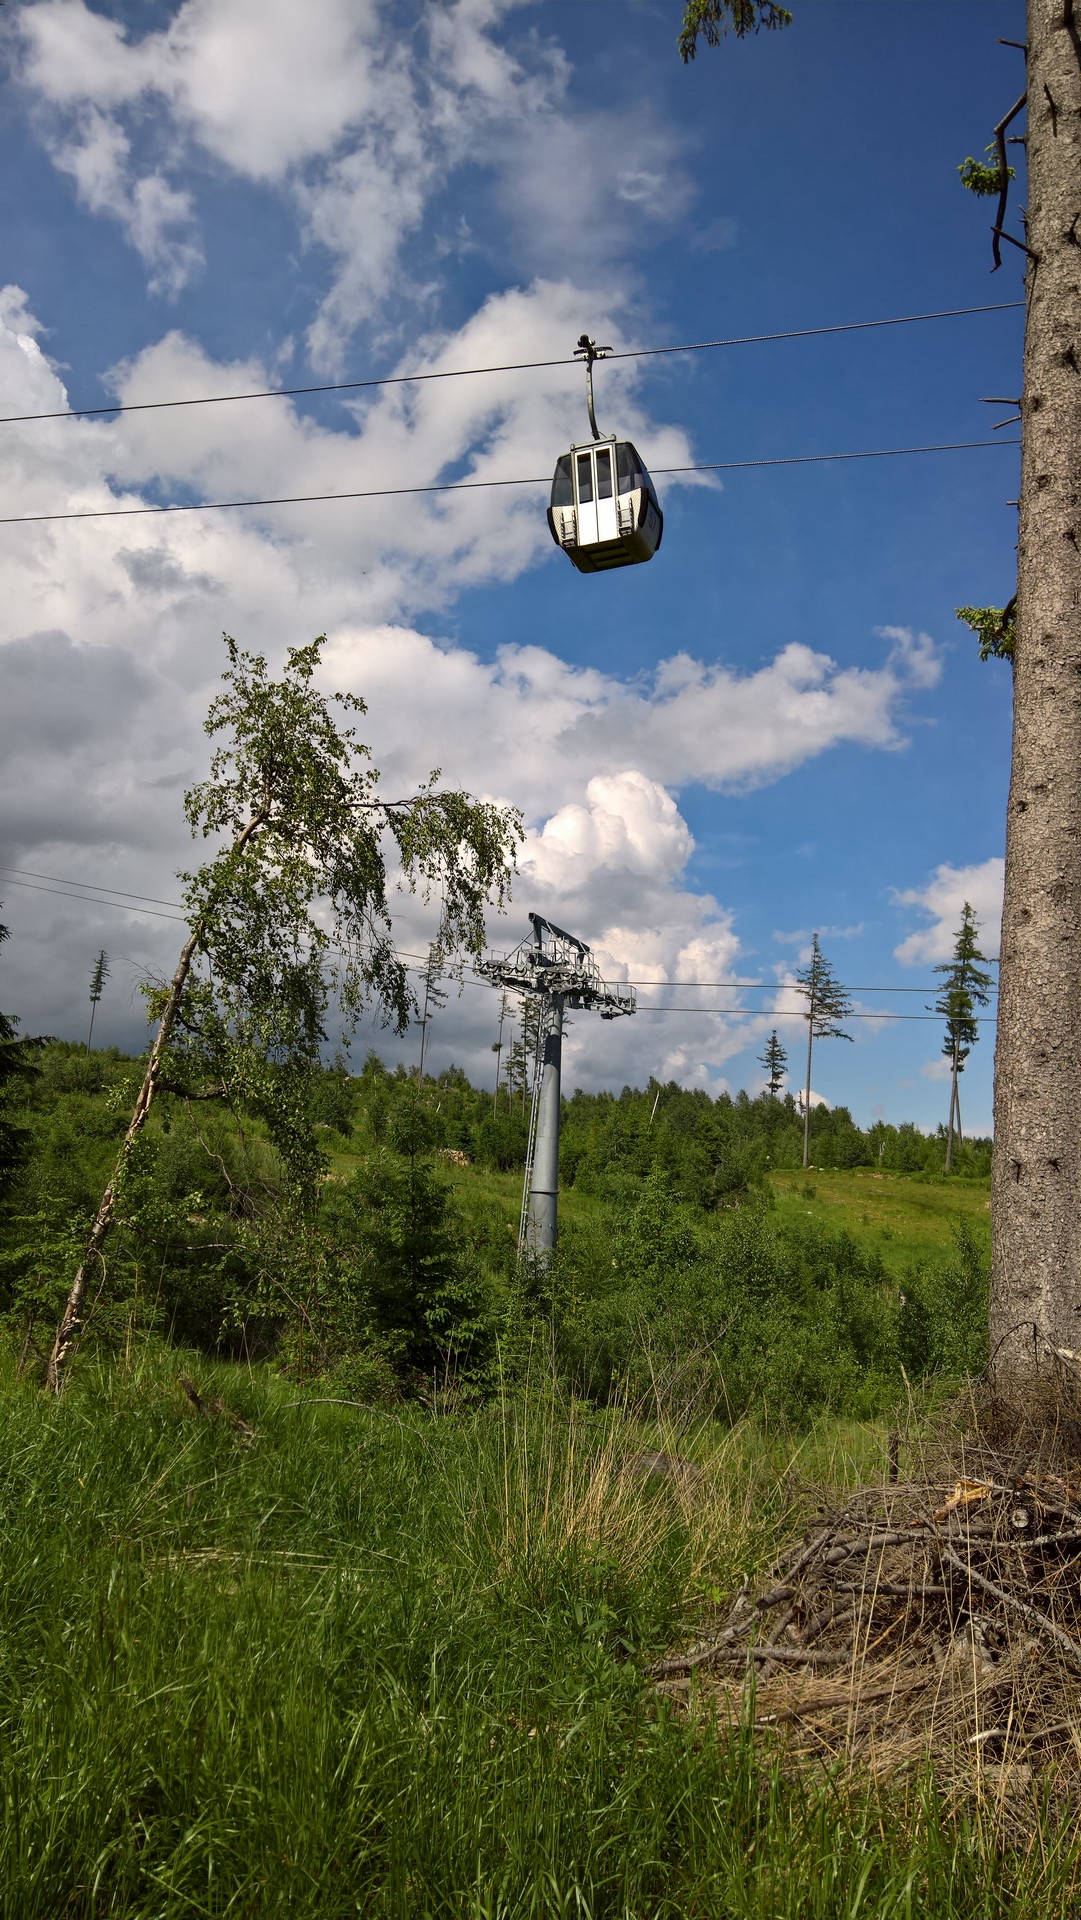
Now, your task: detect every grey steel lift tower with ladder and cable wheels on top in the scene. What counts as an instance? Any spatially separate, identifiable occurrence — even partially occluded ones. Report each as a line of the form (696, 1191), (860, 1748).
(476, 914), (637, 1260)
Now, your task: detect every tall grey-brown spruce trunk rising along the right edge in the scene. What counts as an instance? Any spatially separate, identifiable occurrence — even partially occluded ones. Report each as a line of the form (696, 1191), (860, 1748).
(991, 0), (1081, 1394)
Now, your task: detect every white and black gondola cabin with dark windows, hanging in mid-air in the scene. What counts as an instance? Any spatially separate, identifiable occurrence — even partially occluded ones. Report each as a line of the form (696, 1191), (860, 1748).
(547, 436), (664, 574)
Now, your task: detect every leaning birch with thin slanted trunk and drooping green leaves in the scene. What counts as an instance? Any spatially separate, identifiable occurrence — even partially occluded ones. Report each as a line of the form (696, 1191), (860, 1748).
(46, 636), (520, 1394)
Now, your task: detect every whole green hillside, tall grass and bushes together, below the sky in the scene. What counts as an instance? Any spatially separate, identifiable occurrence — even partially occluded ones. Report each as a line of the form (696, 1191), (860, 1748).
(0, 1043), (1052, 1920)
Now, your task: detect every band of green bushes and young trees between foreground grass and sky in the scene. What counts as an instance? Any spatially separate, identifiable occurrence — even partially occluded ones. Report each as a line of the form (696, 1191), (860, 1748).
(0, 1043), (989, 1423)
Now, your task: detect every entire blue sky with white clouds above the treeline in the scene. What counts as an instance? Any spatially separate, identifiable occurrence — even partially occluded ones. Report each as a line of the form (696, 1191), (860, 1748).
(0, 0), (1023, 1129)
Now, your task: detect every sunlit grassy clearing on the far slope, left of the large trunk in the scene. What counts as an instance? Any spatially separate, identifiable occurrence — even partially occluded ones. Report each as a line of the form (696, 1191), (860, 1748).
(770, 1167), (991, 1271)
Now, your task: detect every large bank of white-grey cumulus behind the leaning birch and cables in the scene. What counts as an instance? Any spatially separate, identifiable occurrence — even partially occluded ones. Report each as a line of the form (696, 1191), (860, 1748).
(0, 282), (940, 1089)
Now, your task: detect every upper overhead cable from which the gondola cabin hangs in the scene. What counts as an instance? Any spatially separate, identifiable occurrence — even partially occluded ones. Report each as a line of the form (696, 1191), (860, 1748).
(0, 300), (1023, 426)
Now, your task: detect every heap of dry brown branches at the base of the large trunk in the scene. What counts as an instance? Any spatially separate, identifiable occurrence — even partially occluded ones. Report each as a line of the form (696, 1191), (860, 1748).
(651, 1457), (1081, 1793)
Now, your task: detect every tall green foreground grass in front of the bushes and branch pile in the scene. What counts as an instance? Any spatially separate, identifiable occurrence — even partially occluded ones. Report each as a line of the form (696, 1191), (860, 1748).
(0, 1350), (1077, 1920)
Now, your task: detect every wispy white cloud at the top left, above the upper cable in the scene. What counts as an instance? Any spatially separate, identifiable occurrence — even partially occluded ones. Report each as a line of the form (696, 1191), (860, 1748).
(12, 0), (691, 371)
